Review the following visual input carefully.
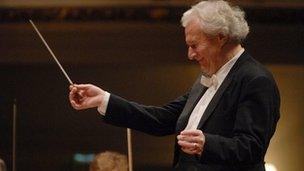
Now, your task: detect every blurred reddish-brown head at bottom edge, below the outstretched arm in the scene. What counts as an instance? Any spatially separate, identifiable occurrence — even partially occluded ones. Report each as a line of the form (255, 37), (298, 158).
(90, 151), (128, 171)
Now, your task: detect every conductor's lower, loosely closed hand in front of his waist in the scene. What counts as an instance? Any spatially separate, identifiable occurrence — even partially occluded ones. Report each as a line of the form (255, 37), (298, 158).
(177, 130), (205, 155)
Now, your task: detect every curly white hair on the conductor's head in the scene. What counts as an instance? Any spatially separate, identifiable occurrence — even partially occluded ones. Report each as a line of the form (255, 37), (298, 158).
(181, 0), (249, 43)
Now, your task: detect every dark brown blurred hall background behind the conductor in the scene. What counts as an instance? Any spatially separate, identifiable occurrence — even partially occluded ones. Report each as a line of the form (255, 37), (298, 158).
(0, 0), (304, 171)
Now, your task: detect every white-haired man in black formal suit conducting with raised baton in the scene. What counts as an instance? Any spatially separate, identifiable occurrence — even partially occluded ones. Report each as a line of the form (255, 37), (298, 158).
(70, 0), (280, 171)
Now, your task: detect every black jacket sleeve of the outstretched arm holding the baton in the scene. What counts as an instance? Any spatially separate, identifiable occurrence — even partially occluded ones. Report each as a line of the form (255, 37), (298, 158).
(103, 93), (188, 136)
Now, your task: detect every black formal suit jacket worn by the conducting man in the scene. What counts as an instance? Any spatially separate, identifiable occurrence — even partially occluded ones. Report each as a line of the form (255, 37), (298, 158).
(104, 51), (280, 171)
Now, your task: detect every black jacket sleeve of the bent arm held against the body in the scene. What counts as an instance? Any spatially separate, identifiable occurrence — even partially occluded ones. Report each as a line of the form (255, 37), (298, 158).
(201, 76), (280, 164)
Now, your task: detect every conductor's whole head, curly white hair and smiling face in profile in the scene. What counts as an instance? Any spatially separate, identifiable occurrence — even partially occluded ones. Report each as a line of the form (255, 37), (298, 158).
(181, 0), (249, 76)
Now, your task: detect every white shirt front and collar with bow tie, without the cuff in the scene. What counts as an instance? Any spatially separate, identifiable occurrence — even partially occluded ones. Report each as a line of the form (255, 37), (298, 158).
(185, 48), (244, 130)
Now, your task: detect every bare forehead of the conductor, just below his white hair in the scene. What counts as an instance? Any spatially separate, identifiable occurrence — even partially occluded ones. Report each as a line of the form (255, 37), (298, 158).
(185, 20), (204, 43)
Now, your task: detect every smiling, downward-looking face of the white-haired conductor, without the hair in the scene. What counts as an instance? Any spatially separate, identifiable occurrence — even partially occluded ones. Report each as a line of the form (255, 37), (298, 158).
(185, 20), (221, 76)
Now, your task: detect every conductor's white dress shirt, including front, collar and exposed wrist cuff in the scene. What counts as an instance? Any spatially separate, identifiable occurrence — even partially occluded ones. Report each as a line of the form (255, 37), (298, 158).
(97, 48), (244, 125)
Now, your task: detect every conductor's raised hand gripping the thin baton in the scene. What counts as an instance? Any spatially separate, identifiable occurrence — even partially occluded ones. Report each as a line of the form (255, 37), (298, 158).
(69, 84), (105, 110)
